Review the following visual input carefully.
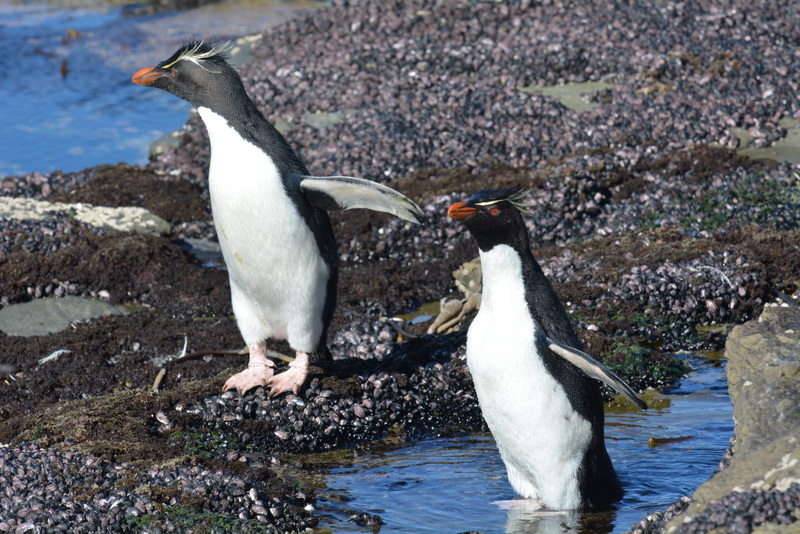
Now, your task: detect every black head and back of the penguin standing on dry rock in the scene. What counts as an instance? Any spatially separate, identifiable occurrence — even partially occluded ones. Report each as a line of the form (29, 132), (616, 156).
(144, 41), (339, 359)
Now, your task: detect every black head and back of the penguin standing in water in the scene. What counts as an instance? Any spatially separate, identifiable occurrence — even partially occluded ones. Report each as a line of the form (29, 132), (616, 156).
(454, 189), (623, 510)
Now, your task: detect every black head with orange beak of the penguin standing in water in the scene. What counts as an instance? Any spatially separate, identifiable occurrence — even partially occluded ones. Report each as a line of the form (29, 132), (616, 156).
(447, 187), (530, 251)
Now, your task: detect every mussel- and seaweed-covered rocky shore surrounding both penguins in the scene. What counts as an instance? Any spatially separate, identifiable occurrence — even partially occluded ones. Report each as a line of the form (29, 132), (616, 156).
(0, 1), (800, 532)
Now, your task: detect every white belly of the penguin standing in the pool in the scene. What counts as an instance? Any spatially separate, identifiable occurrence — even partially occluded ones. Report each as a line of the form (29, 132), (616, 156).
(467, 245), (591, 510)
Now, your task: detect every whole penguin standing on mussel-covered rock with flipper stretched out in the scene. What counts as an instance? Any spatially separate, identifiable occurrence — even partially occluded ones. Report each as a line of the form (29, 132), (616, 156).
(132, 41), (423, 396)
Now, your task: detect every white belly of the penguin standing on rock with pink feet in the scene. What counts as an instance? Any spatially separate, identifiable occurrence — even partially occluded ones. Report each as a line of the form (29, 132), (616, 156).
(198, 108), (328, 352)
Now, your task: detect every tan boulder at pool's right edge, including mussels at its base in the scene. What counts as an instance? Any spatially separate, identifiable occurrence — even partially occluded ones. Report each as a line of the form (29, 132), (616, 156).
(633, 303), (800, 534)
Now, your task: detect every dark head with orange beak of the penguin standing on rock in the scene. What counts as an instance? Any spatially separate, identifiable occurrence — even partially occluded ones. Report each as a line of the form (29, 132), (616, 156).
(131, 41), (244, 111)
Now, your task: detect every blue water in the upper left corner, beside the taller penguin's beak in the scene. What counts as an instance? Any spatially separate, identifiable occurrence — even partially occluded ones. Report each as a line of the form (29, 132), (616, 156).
(0, 2), (189, 176)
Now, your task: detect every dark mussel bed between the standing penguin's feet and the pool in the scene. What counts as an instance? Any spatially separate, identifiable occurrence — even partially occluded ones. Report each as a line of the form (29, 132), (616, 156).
(186, 333), (486, 453)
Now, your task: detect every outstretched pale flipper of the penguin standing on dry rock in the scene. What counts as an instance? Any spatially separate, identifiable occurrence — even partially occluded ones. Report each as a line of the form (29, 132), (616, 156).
(299, 176), (425, 224)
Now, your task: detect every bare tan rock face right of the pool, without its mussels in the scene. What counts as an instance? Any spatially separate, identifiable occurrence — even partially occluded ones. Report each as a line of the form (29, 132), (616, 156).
(666, 307), (800, 532)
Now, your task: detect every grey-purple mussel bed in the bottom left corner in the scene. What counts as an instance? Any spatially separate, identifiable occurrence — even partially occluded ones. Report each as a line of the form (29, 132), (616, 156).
(0, 443), (312, 533)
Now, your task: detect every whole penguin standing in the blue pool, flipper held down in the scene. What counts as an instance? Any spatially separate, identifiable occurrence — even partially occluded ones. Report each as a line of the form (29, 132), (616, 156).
(448, 189), (647, 511)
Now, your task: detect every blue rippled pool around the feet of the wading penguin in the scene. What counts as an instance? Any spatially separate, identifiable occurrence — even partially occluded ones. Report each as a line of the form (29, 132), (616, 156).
(320, 358), (733, 534)
